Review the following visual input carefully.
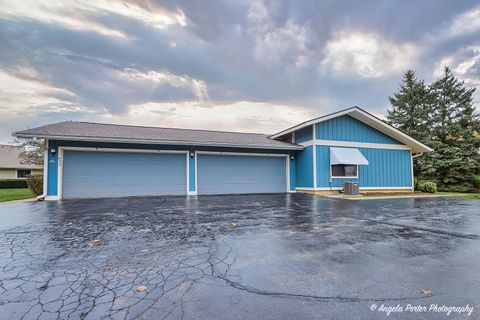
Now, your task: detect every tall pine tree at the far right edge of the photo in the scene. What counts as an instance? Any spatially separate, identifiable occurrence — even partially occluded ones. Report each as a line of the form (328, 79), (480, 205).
(419, 67), (480, 192)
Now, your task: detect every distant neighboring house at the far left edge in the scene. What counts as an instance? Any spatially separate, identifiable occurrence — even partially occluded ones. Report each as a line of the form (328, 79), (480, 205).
(0, 144), (43, 179)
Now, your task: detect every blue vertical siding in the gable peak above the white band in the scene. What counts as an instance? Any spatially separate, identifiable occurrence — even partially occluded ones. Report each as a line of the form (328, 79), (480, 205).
(315, 115), (401, 144)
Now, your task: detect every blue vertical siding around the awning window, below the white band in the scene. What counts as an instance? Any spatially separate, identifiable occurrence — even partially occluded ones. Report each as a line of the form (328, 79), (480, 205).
(316, 146), (412, 188)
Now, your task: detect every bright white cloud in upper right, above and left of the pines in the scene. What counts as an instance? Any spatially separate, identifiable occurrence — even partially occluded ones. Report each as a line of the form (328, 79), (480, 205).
(320, 31), (418, 78)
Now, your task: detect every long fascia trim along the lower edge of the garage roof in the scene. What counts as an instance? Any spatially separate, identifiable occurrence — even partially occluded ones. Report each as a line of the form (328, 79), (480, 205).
(13, 134), (303, 150)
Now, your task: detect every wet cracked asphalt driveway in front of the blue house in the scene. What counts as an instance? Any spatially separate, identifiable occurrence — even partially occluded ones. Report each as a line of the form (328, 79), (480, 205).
(0, 194), (480, 319)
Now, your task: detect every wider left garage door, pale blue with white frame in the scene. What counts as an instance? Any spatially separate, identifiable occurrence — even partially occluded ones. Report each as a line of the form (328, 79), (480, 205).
(62, 150), (186, 198)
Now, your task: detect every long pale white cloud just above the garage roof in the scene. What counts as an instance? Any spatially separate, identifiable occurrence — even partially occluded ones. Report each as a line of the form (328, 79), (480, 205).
(100, 101), (313, 133)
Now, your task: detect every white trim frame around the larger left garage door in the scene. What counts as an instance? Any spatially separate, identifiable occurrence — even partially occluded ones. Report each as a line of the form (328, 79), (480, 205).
(57, 146), (190, 200)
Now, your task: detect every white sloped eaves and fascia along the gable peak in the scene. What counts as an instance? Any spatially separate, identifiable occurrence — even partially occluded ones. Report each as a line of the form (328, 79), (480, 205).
(270, 107), (433, 153)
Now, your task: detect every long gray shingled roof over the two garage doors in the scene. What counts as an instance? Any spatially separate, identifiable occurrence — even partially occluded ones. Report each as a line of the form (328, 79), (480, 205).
(13, 121), (303, 149)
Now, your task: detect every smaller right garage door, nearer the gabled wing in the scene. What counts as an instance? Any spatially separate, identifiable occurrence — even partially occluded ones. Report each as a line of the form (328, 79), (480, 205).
(197, 154), (287, 194)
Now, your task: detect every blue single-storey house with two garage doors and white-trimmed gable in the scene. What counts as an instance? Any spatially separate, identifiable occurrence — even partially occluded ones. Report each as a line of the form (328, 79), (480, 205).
(14, 107), (432, 199)
